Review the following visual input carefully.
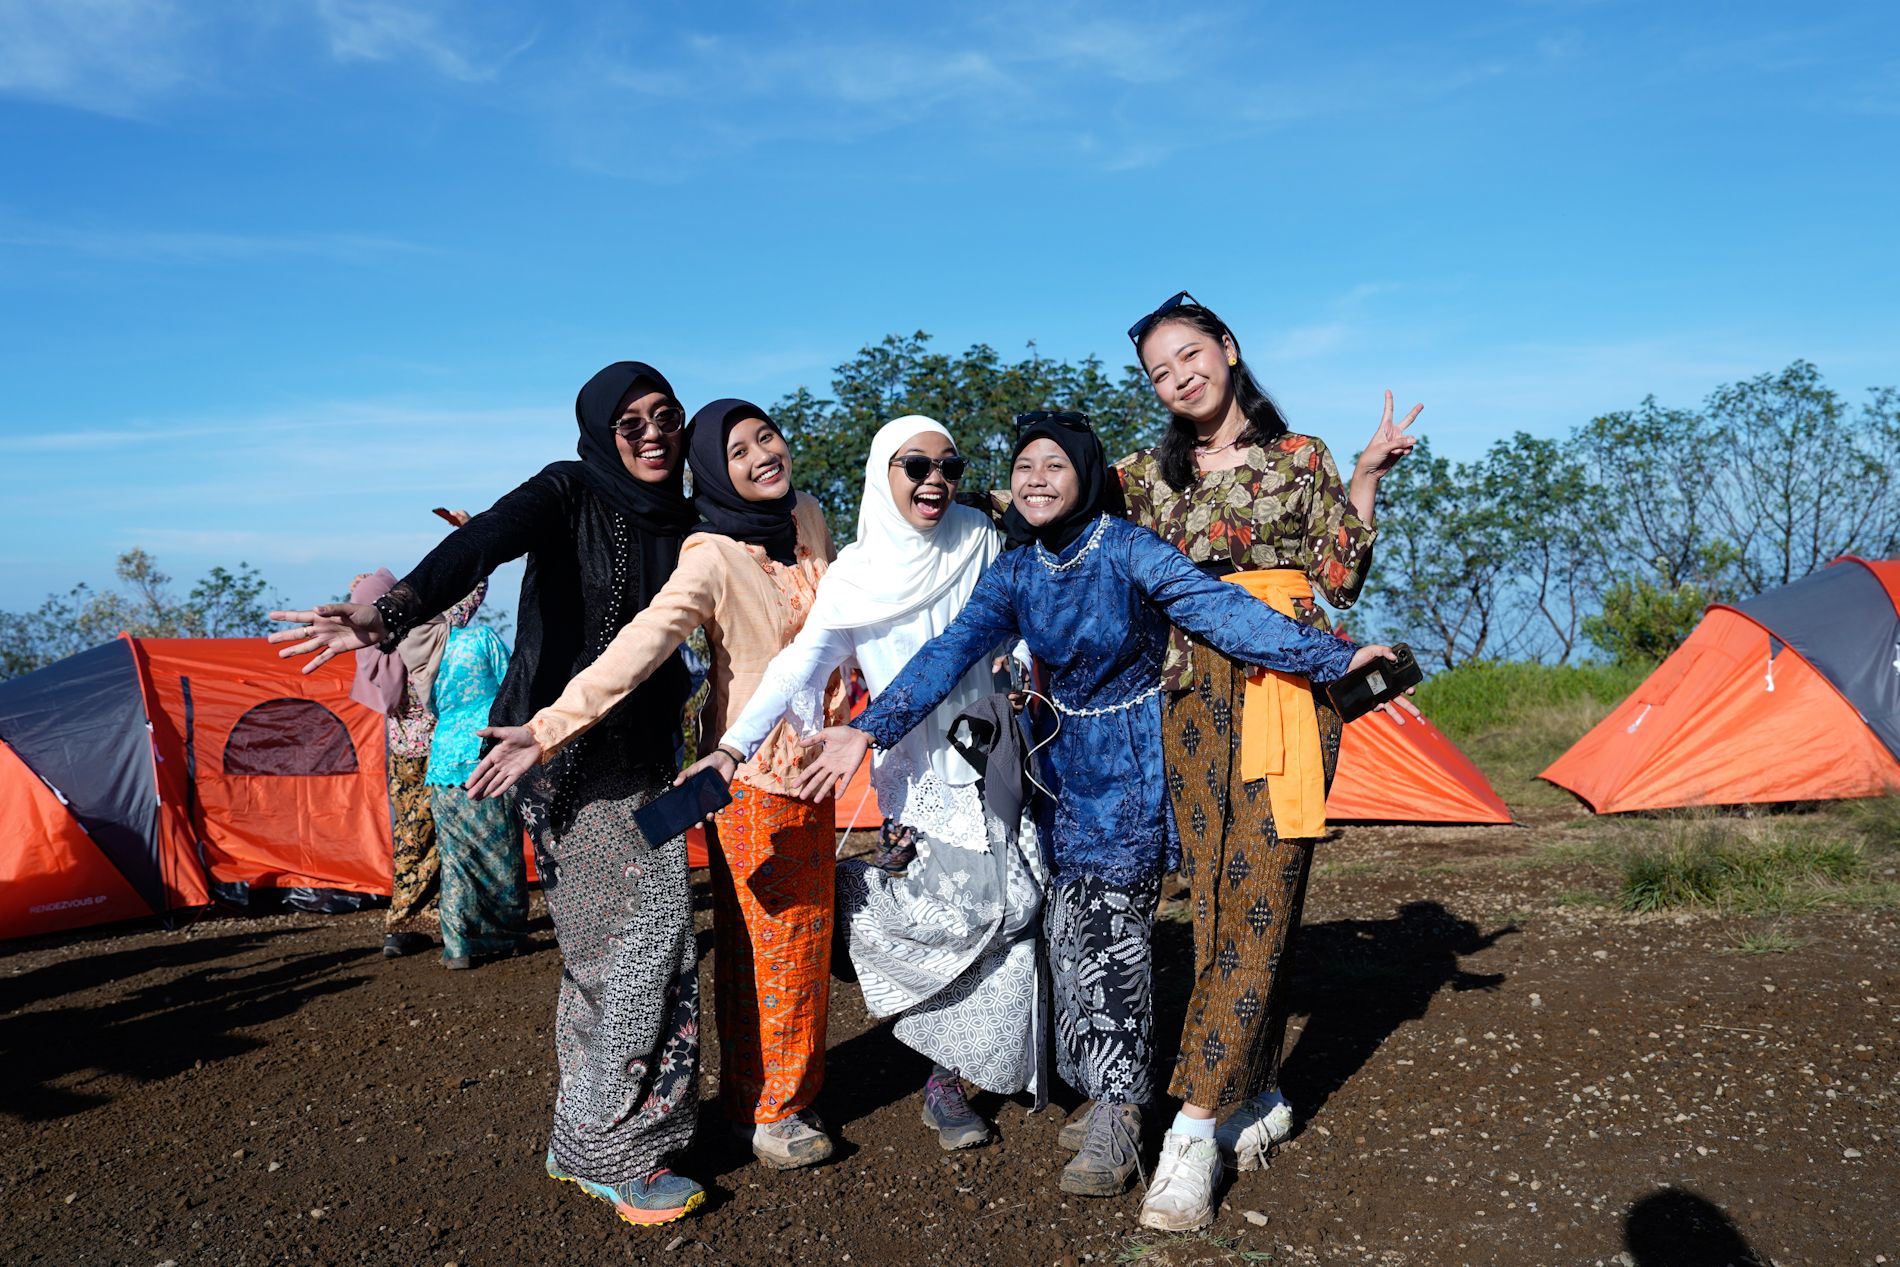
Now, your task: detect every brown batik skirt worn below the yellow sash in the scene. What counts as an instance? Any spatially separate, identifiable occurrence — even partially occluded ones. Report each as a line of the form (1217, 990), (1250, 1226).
(1161, 642), (1343, 1109)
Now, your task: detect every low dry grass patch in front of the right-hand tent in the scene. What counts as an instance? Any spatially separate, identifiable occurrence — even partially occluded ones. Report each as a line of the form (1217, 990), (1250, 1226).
(1617, 798), (1900, 912)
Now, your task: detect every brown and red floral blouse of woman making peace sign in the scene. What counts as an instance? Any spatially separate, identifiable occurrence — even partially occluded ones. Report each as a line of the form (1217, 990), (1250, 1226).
(1117, 433), (1378, 691)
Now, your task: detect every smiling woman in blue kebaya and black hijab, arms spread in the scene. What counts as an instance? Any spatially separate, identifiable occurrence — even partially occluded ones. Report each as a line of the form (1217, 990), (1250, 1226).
(800, 412), (1391, 1197)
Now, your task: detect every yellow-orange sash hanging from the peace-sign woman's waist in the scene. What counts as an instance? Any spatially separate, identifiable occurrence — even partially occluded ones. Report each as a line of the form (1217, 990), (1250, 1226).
(1222, 568), (1326, 840)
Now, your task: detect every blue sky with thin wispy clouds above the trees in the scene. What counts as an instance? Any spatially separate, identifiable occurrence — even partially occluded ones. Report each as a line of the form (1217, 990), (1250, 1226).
(0, 0), (1900, 623)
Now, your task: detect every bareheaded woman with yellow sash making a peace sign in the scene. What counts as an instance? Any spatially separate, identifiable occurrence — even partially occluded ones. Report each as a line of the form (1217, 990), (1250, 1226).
(1121, 291), (1423, 1229)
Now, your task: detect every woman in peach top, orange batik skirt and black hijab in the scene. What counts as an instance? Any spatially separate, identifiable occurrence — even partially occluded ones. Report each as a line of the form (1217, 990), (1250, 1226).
(469, 399), (844, 1168)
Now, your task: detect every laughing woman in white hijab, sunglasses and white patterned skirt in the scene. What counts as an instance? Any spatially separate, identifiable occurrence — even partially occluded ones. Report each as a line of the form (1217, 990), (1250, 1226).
(682, 414), (1047, 1149)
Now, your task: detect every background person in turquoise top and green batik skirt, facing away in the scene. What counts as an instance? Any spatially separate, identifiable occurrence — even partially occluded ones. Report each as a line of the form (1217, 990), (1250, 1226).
(428, 585), (528, 969)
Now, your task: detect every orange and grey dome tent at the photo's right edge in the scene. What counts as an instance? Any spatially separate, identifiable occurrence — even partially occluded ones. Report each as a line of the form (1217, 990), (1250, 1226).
(1541, 557), (1900, 813)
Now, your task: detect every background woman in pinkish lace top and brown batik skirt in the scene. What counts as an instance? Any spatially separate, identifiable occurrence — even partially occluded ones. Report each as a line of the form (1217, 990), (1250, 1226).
(350, 568), (488, 959)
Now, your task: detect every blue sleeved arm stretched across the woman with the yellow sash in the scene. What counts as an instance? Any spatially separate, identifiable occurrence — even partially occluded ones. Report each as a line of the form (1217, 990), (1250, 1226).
(1132, 532), (1359, 682)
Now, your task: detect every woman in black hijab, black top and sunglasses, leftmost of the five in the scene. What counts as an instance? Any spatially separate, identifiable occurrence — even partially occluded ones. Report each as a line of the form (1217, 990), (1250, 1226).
(270, 361), (722, 1223)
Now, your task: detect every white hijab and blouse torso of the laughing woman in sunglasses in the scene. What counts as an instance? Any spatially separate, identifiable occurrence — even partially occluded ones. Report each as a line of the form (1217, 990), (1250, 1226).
(808, 414), (1003, 785)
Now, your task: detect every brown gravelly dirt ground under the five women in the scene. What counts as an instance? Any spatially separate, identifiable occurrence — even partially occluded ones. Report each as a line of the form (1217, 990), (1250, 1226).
(0, 815), (1900, 1267)
